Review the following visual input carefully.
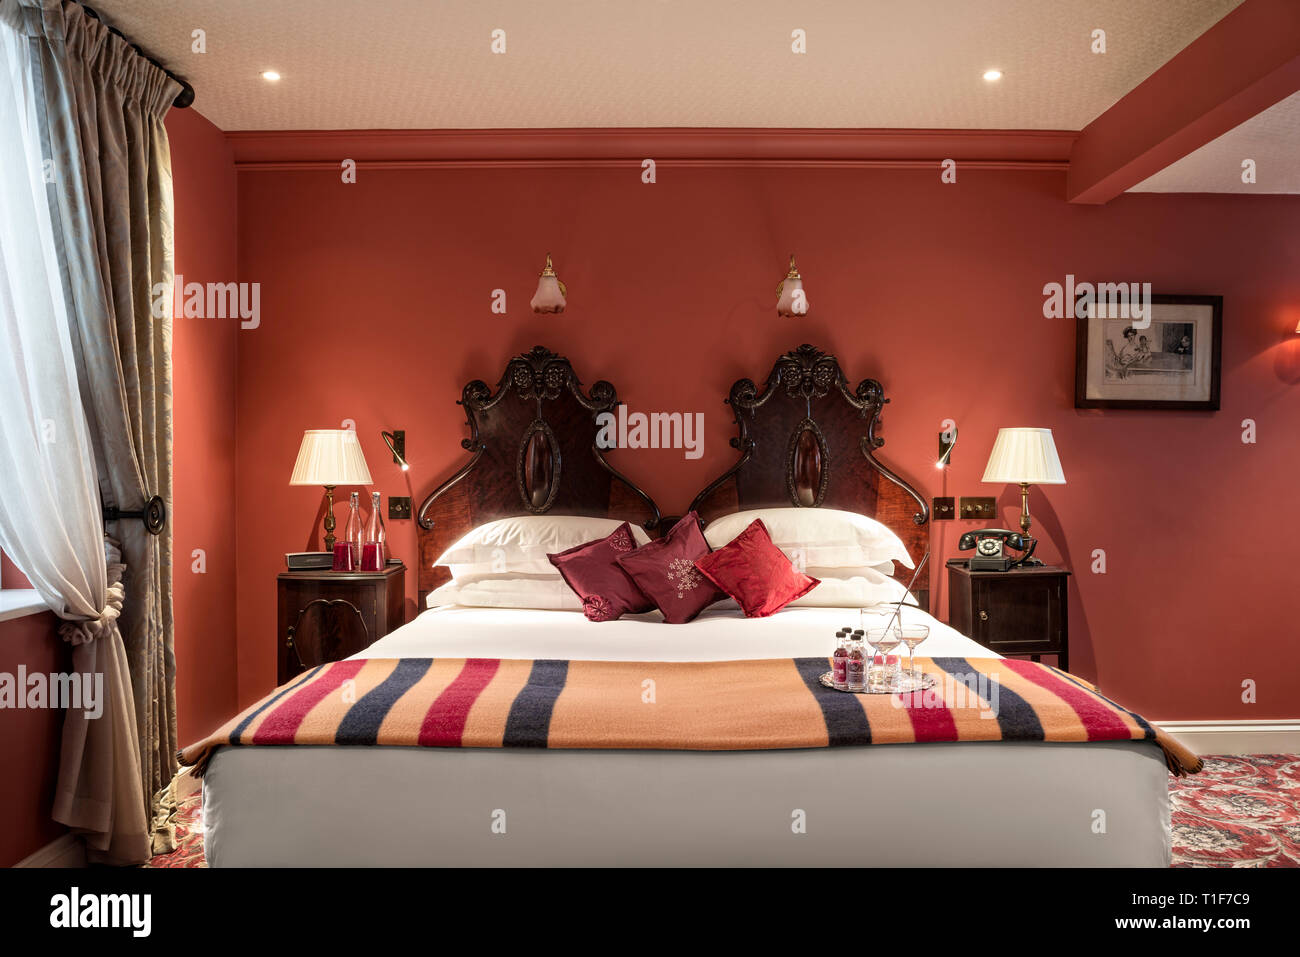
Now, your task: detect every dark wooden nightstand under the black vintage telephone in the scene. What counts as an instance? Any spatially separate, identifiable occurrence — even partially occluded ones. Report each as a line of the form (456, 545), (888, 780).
(948, 559), (1070, 671)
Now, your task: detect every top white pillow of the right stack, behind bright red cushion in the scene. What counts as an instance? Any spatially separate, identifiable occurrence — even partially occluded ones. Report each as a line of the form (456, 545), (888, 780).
(705, 508), (913, 566)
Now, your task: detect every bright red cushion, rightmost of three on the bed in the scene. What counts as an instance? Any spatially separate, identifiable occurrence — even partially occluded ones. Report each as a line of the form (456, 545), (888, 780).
(696, 519), (822, 618)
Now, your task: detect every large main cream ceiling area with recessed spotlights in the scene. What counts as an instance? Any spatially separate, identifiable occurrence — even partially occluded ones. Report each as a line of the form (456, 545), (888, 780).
(88, 0), (1242, 130)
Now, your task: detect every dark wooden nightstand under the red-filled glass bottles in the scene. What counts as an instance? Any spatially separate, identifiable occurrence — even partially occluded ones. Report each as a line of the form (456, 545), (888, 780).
(278, 564), (406, 684)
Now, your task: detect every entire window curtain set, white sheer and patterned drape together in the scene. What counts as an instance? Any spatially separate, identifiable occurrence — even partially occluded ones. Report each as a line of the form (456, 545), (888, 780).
(0, 0), (179, 863)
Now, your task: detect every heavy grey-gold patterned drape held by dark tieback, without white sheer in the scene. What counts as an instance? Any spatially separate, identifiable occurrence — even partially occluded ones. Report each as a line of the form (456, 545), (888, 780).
(10, 0), (181, 858)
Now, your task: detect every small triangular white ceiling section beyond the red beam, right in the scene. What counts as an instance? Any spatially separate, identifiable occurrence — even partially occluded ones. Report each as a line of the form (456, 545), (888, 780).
(1130, 94), (1300, 192)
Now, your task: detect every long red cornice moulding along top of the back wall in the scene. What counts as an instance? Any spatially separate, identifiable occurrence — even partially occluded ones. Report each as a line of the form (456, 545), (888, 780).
(226, 129), (1079, 172)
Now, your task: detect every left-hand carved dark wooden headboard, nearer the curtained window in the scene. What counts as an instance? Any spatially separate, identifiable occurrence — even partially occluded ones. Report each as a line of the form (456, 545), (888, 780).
(416, 346), (659, 611)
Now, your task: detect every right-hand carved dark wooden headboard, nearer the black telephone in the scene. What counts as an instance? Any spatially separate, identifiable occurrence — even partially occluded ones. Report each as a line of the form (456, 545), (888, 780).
(690, 345), (932, 609)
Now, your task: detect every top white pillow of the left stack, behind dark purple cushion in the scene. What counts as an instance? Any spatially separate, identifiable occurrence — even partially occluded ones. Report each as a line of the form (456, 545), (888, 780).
(433, 515), (650, 579)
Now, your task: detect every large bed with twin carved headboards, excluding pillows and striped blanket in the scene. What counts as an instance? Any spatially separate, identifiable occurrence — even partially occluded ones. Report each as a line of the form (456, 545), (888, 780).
(203, 346), (1170, 866)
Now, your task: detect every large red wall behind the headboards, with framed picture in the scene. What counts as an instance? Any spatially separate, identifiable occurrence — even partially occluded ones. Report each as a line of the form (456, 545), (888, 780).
(235, 165), (1300, 719)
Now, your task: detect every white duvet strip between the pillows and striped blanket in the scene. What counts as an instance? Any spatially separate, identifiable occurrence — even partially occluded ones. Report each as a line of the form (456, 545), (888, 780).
(352, 605), (1000, 662)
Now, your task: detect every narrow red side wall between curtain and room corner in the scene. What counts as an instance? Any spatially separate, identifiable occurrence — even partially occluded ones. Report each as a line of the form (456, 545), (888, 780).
(166, 109), (239, 744)
